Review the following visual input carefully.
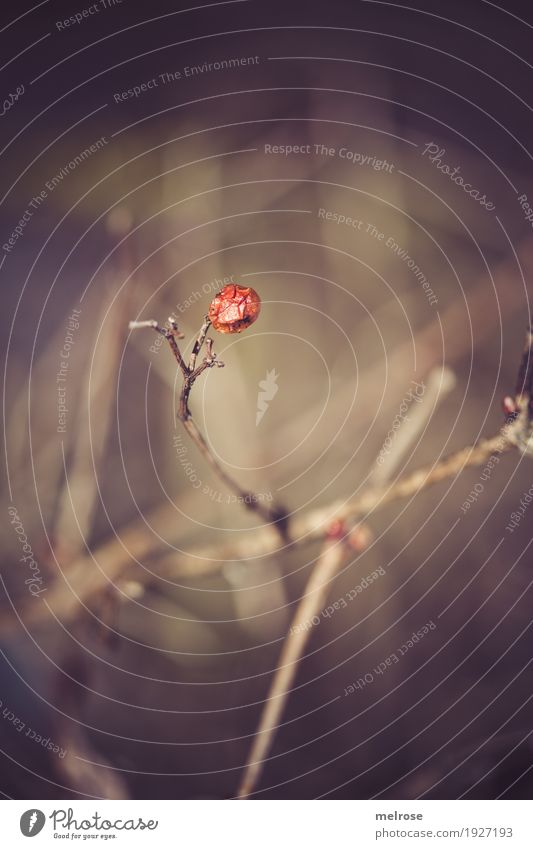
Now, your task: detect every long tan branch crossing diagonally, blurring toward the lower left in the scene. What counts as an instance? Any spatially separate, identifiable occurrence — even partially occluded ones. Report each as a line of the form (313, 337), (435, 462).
(4, 332), (530, 634)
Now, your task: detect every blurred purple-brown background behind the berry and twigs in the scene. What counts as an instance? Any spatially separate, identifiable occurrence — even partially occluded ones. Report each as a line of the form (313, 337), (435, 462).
(0, 0), (533, 799)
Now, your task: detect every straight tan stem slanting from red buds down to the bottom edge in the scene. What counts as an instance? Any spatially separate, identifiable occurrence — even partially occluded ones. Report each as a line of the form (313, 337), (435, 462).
(237, 539), (349, 799)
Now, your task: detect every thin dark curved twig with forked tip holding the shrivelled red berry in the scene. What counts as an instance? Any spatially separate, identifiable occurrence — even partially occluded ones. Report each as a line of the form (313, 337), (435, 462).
(129, 316), (287, 528)
